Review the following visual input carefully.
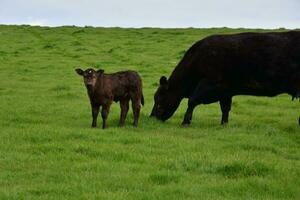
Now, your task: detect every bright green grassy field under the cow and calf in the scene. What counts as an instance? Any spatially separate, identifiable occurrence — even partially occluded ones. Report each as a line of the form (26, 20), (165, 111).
(0, 25), (300, 200)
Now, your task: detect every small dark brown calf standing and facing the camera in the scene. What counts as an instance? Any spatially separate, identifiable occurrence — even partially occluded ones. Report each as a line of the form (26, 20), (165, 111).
(76, 68), (144, 129)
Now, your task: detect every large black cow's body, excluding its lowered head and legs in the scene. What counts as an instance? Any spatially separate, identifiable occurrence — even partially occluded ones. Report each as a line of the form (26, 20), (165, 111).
(170, 31), (300, 96)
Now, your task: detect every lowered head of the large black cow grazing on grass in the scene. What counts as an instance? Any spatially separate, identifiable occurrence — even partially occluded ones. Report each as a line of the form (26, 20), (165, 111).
(150, 76), (180, 121)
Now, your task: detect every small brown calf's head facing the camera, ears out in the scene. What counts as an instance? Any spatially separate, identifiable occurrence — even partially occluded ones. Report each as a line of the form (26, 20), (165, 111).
(75, 68), (104, 88)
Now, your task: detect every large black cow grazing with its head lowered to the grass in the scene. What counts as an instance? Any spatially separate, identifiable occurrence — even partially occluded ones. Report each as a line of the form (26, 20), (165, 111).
(151, 31), (300, 126)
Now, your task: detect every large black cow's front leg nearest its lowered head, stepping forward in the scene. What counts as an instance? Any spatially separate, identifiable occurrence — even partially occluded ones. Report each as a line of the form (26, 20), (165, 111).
(182, 81), (220, 127)
